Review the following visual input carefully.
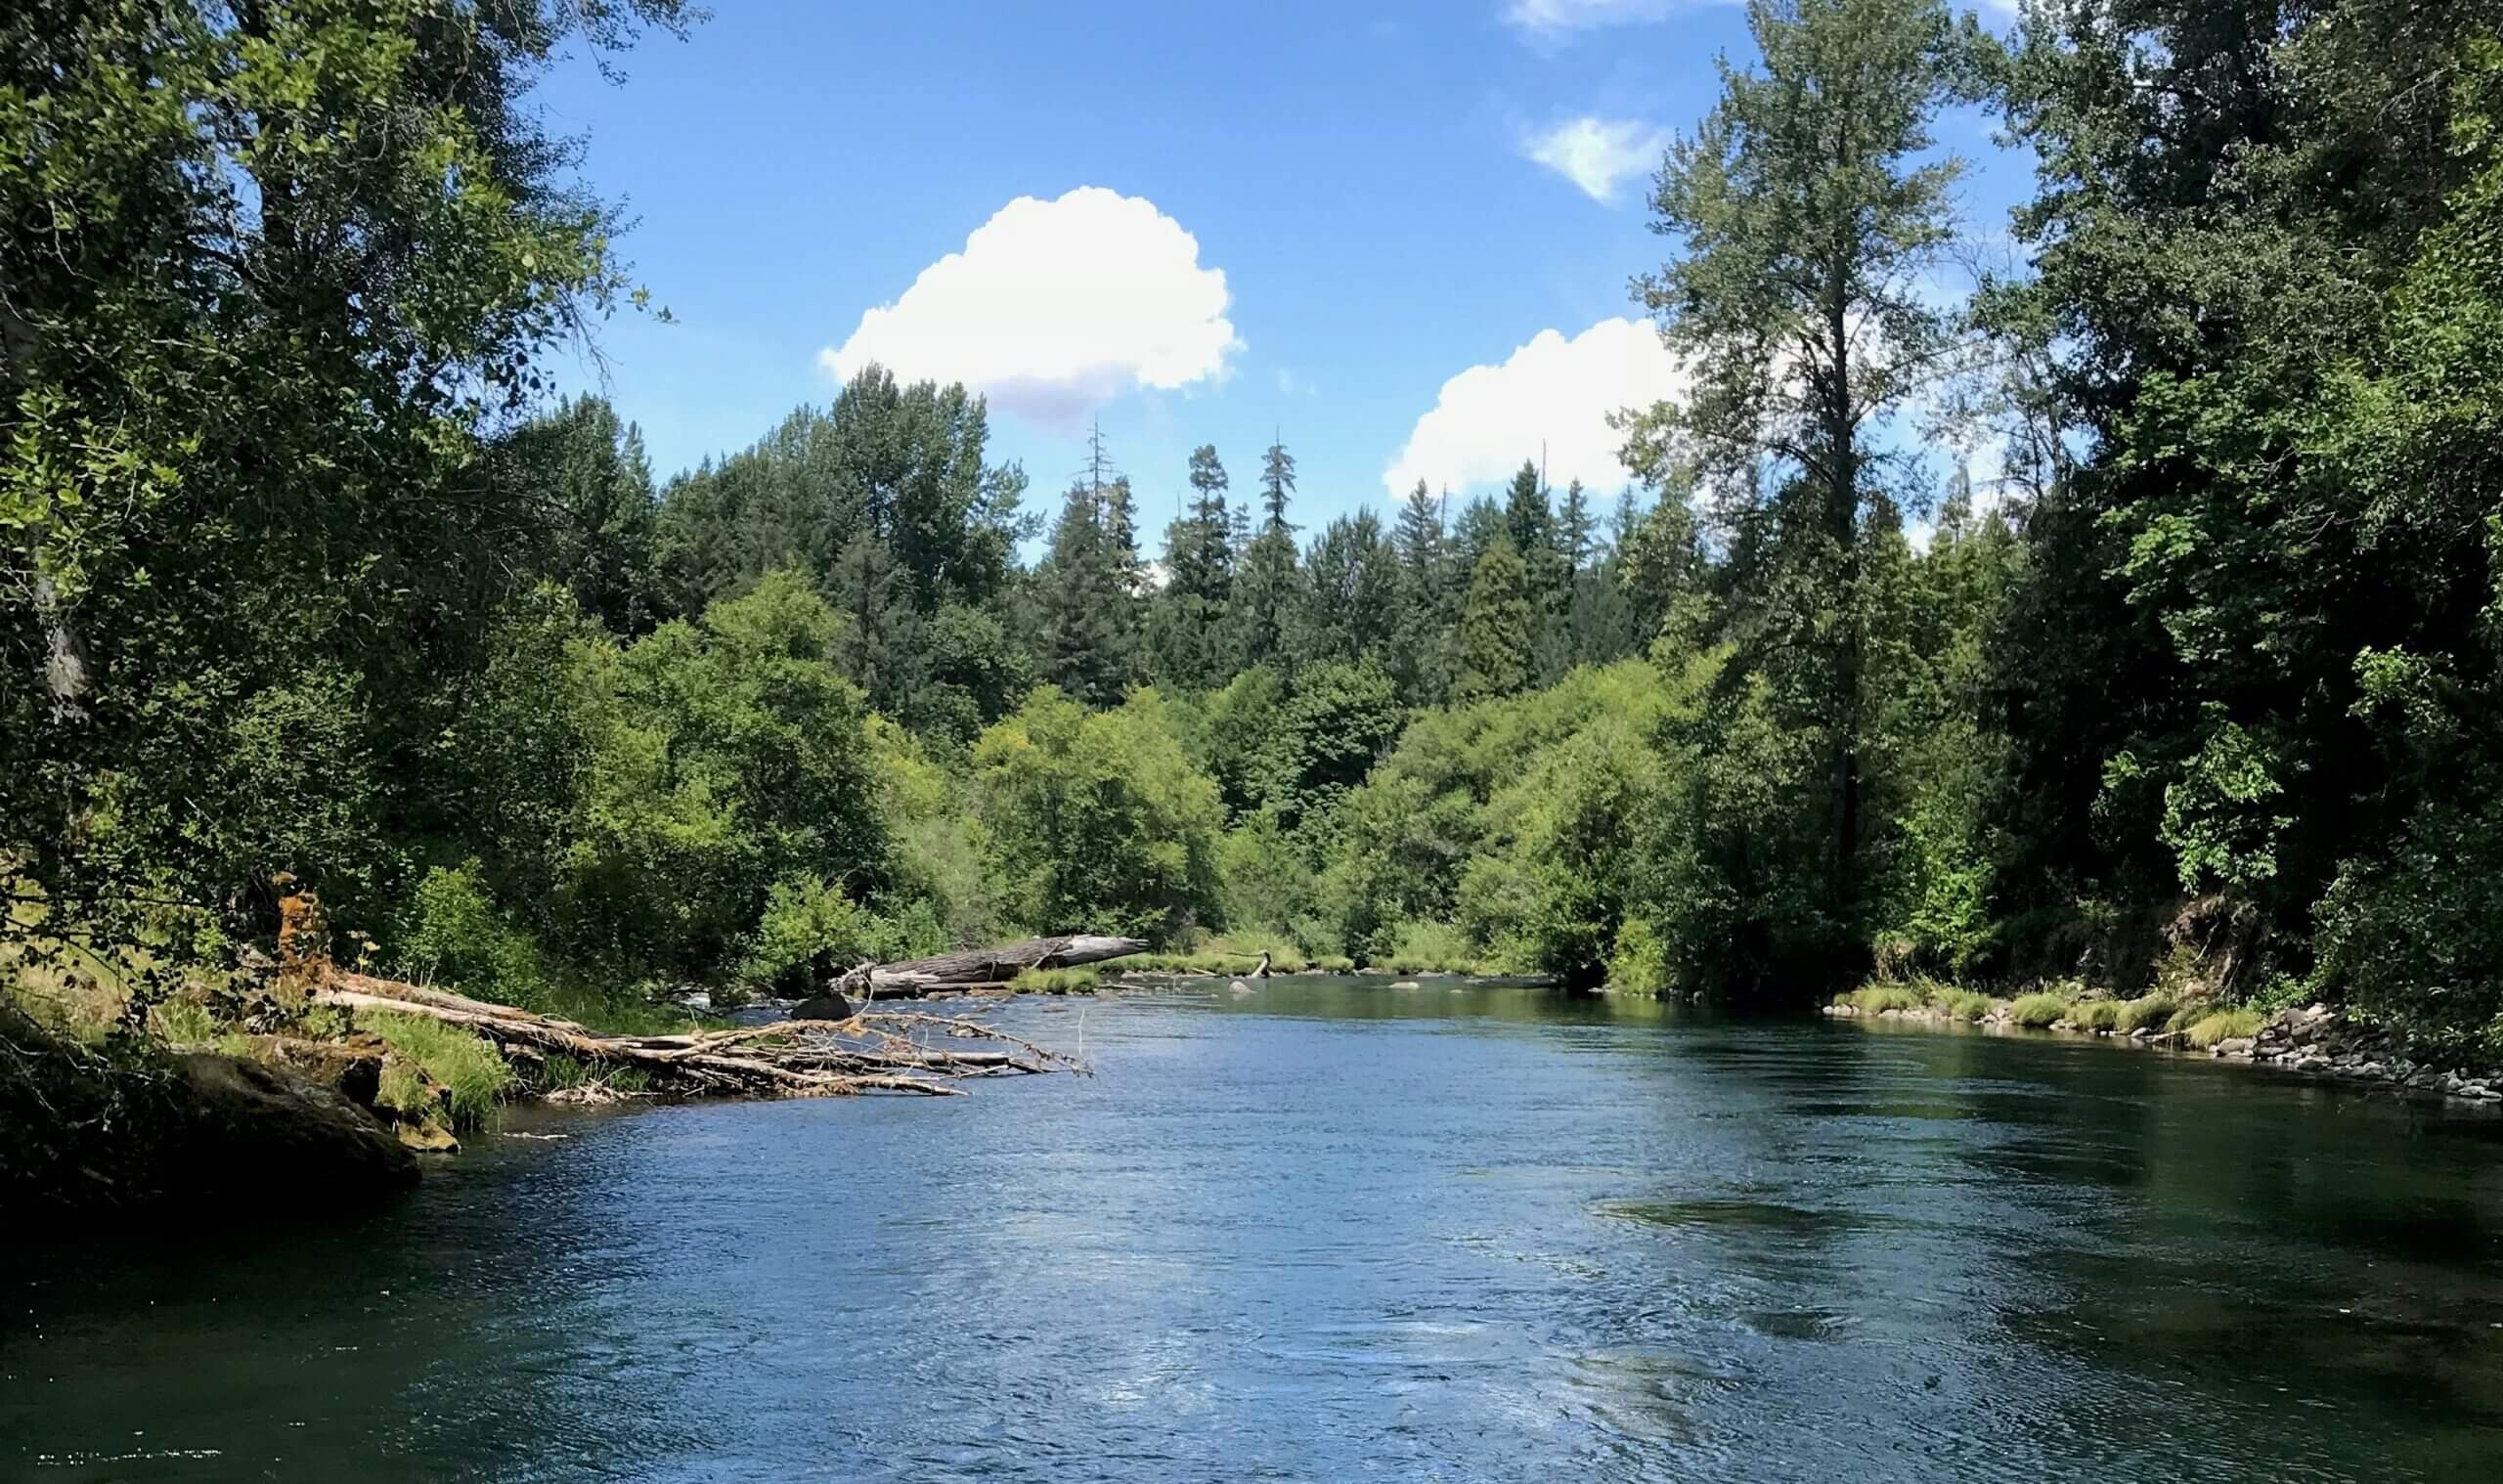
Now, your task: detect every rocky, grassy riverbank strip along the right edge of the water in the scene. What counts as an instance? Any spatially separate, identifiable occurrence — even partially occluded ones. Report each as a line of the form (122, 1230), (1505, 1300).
(1824, 983), (2503, 1104)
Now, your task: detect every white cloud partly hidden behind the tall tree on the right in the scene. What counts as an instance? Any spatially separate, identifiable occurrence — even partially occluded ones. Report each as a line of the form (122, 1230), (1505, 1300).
(1382, 318), (1685, 498)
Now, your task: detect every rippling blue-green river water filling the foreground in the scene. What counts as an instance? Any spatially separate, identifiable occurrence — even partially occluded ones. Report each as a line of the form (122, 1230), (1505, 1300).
(0, 979), (2503, 1484)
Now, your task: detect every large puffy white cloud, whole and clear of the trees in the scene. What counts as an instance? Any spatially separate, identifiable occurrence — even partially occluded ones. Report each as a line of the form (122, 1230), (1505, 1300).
(816, 185), (1244, 425)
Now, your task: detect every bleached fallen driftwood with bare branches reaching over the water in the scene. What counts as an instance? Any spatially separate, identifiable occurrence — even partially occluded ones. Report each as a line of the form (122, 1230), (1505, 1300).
(310, 969), (1086, 1099)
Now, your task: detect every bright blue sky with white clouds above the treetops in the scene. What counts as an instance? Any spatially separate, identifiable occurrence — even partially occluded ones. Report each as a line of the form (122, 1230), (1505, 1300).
(538, 0), (2028, 526)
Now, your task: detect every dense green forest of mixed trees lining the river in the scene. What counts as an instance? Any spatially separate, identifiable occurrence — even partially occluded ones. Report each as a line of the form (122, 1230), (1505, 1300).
(15, 0), (2503, 1051)
